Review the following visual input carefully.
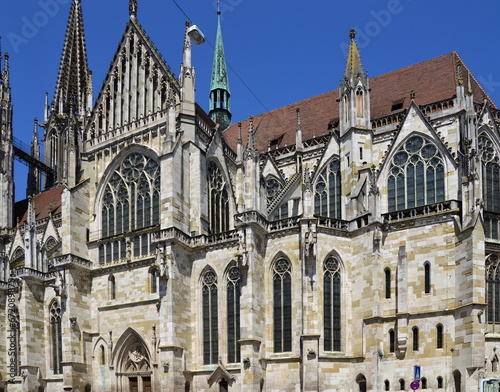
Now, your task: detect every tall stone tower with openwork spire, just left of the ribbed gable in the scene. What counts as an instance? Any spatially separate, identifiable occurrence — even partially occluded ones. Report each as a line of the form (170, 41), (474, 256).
(43, 0), (93, 188)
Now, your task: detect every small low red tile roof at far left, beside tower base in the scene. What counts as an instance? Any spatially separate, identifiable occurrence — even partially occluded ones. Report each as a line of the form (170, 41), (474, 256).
(14, 185), (65, 225)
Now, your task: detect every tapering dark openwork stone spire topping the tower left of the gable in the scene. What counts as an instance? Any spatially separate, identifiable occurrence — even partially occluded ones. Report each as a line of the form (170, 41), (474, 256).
(53, 0), (91, 115)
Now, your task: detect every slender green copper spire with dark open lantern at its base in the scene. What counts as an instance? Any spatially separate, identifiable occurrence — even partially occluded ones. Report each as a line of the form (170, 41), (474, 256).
(209, 10), (231, 130)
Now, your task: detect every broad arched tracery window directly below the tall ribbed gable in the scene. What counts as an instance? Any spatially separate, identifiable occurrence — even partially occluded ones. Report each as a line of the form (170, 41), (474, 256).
(101, 153), (160, 237)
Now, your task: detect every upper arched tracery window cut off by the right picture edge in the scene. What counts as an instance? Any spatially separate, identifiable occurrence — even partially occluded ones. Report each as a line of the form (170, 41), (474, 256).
(478, 134), (500, 212)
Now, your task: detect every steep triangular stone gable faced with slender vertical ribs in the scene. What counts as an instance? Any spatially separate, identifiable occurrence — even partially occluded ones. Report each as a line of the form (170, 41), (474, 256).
(84, 20), (181, 145)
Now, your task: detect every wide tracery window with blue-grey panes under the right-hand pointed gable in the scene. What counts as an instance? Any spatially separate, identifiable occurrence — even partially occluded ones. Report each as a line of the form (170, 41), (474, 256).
(387, 136), (445, 211)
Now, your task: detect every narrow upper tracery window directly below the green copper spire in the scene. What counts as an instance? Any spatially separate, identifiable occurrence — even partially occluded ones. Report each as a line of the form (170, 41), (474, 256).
(208, 161), (229, 233)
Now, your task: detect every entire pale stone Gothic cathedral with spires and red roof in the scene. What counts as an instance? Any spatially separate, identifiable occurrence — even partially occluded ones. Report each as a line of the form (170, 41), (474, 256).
(0, 0), (500, 392)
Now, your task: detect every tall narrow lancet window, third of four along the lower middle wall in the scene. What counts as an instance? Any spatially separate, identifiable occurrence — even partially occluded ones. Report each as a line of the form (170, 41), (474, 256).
(273, 258), (292, 353)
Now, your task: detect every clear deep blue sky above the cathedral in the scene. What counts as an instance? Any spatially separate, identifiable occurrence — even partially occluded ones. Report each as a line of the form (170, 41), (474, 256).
(0, 0), (500, 199)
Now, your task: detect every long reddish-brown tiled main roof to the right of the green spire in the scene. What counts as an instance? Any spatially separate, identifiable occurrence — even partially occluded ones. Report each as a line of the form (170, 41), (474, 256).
(224, 52), (496, 152)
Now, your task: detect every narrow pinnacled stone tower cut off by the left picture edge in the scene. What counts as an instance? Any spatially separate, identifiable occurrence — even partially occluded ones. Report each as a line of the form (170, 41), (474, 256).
(0, 48), (14, 230)
